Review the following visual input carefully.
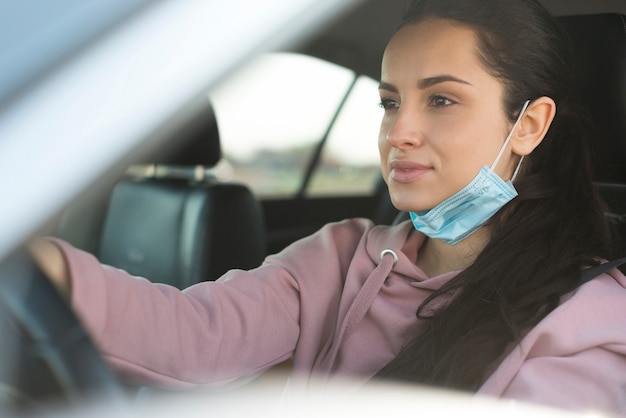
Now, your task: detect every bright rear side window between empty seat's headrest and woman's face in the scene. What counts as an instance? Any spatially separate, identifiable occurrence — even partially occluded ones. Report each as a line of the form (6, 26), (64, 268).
(209, 53), (382, 198)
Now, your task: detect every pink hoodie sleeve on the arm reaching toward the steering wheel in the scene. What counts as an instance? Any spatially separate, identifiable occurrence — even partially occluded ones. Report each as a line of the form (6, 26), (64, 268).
(47, 220), (371, 387)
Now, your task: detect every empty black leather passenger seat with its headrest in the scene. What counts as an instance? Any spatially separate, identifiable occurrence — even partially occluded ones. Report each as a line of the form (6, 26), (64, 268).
(57, 100), (265, 288)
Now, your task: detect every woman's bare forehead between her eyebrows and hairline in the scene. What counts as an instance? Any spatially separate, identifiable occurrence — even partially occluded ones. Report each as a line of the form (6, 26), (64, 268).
(381, 19), (489, 81)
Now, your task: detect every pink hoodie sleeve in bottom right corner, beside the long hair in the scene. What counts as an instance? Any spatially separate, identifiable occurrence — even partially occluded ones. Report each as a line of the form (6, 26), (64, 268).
(479, 269), (626, 415)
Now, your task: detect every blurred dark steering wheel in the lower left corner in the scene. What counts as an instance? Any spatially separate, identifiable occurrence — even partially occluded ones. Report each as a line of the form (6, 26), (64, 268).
(0, 251), (124, 407)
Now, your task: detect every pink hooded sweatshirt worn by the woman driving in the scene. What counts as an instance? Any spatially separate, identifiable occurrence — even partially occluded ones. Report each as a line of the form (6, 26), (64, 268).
(56, 219), (626, 413)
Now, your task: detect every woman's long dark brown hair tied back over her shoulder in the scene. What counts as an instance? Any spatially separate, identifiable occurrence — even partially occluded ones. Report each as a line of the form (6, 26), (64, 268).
(377, 0), (612, 391)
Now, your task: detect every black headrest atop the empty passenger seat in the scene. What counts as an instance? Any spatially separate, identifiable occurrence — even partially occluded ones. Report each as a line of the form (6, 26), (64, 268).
(140, 102), (222, 167)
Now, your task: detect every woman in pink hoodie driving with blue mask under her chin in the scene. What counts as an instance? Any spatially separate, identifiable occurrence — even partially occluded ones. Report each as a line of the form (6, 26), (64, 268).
(33, 0), (626, 412)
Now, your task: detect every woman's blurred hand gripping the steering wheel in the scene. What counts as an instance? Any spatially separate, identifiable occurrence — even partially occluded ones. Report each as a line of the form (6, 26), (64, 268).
(28, 238), (71, 296)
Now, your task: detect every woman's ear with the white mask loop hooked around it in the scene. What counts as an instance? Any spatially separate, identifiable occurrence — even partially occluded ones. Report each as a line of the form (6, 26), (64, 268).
(511, 96), (556, 155)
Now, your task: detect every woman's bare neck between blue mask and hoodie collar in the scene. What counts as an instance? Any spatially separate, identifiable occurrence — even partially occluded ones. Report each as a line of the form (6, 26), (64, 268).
(415, 227), (489, 277)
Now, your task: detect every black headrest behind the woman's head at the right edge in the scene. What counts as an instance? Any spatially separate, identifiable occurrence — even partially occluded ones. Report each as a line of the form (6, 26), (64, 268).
(560, 14), (626, 183)
